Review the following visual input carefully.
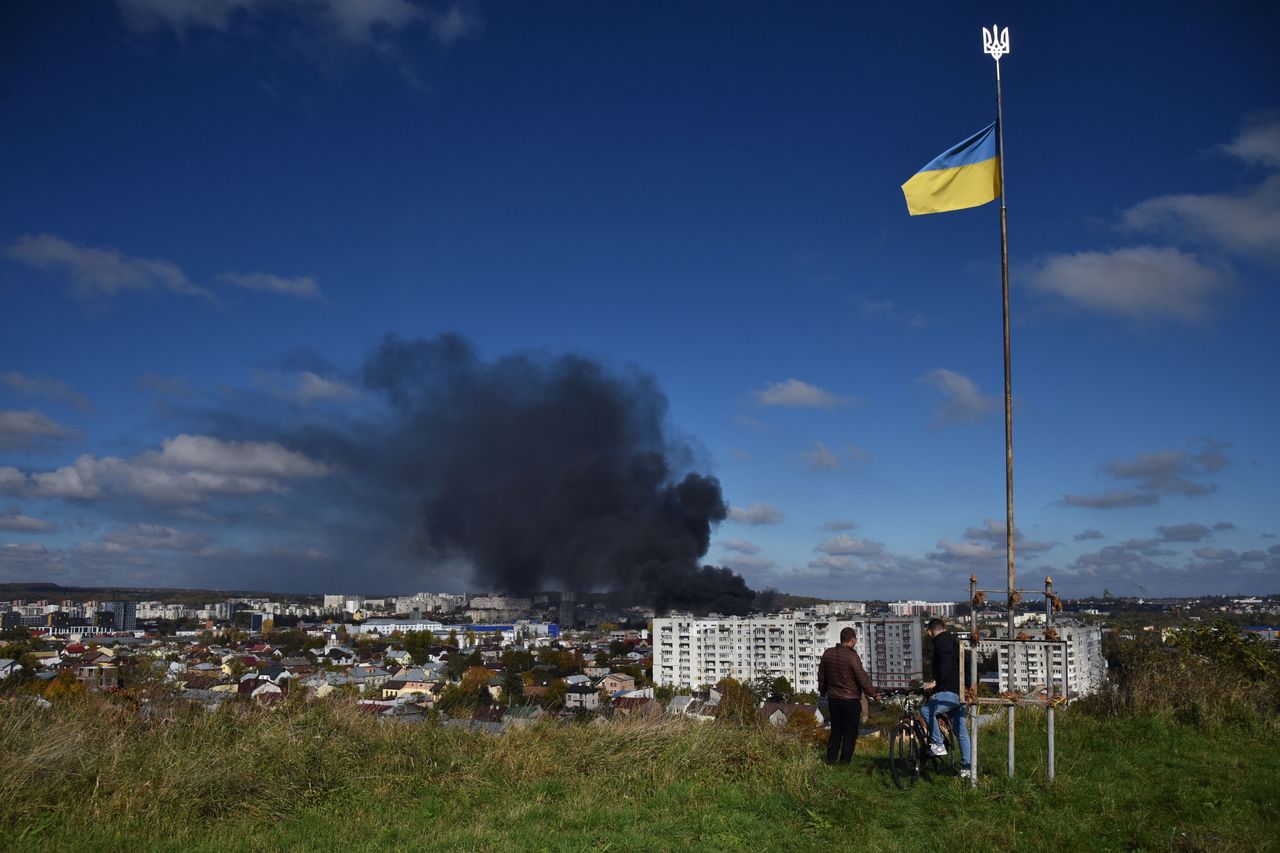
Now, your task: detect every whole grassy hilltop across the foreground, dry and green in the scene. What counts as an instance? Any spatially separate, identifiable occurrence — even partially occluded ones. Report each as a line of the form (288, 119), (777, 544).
(0, 699), (1280, 850)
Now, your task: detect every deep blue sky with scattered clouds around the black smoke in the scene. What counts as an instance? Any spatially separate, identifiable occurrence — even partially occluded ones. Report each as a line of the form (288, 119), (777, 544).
(0, 0), (1280, 598)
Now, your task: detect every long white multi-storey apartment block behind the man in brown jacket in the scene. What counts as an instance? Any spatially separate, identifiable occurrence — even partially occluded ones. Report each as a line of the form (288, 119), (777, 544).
(653, 610), (923, 693)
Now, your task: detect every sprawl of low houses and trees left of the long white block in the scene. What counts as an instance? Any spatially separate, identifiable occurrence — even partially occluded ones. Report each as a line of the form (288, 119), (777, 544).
(0, 625), (824, 733)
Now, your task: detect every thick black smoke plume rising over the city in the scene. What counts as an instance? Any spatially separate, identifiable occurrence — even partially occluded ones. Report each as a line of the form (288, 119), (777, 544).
(357, 334), (754, 613)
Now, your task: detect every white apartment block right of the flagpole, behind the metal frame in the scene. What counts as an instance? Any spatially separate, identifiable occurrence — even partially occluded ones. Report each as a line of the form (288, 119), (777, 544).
(979, 625), (1107, 698)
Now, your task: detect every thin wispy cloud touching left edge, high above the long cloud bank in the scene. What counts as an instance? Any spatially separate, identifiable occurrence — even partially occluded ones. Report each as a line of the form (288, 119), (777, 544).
(4, 234), (216, 301)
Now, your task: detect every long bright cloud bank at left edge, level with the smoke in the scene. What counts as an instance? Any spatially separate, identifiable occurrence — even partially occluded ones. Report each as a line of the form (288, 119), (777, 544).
(0, 434), (330, 505)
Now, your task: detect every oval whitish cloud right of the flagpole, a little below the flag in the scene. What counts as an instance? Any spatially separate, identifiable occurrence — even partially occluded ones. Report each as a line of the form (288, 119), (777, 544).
(1028, 246), (1230, 323)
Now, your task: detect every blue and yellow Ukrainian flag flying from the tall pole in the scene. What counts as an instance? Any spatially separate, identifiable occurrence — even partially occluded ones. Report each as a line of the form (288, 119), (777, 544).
(902, 122), (1000, 216)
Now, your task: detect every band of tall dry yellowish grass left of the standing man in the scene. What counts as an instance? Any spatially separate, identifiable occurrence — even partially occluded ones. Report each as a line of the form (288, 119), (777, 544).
(0, 694), (818, 829)
